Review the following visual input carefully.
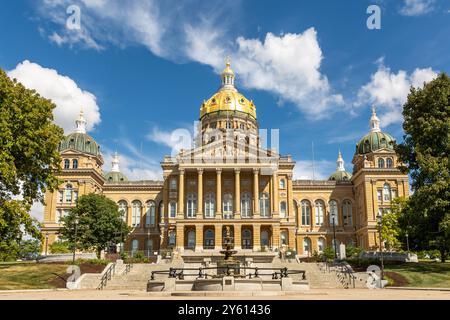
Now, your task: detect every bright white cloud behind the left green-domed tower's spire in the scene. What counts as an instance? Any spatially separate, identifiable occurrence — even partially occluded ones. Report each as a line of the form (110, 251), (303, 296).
(8, 60), (100, 134)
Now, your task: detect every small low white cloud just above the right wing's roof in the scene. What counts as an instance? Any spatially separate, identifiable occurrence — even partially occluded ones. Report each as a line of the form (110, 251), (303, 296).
(293, 160), (336, 180)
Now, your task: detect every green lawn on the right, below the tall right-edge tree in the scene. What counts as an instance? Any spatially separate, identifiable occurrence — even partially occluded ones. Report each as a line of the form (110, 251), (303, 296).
(385, 261), (450, 288)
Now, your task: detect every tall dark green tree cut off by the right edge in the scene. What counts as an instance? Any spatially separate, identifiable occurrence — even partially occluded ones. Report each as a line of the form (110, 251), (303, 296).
(396, 73), (450, 262)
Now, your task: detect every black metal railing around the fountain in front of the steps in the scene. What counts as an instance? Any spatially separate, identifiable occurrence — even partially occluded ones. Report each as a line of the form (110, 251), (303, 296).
(150, 266), (306, 280)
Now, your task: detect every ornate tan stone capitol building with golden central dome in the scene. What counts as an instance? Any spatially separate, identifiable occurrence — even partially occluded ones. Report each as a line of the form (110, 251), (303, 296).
(42, 62), (409, 256)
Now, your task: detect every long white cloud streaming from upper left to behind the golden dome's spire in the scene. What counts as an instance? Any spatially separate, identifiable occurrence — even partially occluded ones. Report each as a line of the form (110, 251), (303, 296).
(39, 0), (343, 119)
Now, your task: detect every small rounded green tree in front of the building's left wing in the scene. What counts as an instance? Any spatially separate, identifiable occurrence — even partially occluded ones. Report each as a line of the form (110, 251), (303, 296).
(60, 193), (131, 258)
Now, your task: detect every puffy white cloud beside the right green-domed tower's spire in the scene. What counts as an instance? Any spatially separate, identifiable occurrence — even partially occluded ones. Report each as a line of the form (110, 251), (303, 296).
(356, 63), (437, 126)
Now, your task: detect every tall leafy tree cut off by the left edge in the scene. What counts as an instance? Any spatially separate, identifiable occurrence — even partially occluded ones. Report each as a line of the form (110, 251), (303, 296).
(0, 69), (63, 247)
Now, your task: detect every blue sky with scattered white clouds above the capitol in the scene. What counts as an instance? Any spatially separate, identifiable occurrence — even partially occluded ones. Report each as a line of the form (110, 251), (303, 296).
(0, 0), (450, 185)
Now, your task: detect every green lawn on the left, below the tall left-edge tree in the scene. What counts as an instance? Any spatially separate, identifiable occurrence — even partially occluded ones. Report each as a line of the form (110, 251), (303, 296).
(0, 263), (67, 290)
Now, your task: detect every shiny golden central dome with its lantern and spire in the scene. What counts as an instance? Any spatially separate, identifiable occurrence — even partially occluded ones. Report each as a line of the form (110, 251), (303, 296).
(200, 59), (256, 120)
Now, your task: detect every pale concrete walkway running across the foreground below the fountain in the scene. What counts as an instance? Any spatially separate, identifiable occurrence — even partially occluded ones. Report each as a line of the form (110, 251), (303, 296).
(0, 289), (450, 300)
